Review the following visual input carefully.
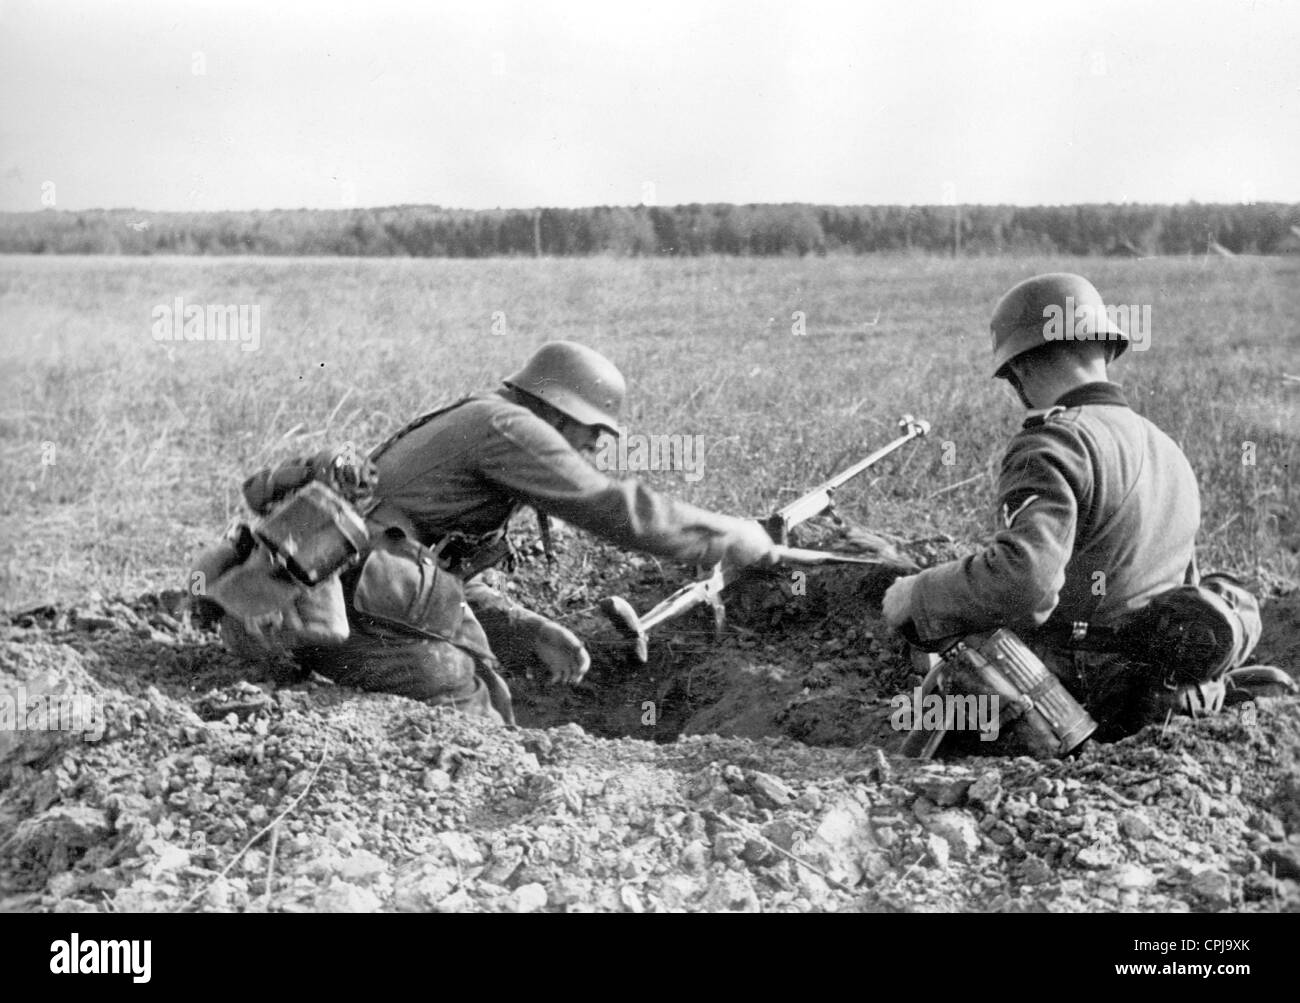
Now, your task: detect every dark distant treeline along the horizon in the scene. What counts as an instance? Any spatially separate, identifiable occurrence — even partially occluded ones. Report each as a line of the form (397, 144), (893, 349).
(0, 203), (1300, 257)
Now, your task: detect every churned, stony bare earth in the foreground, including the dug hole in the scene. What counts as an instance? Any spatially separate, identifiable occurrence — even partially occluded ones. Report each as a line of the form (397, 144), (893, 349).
(0, 542), (1300, 912)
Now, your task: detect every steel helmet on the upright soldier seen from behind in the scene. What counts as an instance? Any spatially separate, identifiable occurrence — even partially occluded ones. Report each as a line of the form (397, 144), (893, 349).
(989, 272), (1128, 378)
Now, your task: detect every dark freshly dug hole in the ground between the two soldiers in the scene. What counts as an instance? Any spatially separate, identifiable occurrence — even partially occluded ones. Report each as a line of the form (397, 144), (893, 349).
(511, 529), (935, 748)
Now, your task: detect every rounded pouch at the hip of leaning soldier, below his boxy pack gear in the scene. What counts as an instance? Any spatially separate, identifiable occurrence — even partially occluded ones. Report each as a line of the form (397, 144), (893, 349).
(352, 529), (465, 643)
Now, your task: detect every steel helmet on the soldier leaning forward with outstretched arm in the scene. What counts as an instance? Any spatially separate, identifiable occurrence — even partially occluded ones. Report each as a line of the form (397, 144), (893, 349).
(504, 342), (628, 435)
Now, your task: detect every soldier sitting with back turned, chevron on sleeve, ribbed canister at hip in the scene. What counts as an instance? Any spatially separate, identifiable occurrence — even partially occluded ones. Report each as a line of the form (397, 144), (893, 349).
(883, 273), (1290, 755)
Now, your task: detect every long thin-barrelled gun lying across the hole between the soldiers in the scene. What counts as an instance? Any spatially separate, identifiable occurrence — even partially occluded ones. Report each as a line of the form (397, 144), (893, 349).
(601, 414), (930, 665)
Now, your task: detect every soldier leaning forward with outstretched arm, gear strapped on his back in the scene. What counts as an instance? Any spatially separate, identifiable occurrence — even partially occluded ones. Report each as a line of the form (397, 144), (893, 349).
(189, 342), (774, 722)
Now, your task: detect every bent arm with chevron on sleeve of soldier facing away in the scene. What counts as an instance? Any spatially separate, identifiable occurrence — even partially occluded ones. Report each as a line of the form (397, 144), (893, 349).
(911, 422), (1092, 641)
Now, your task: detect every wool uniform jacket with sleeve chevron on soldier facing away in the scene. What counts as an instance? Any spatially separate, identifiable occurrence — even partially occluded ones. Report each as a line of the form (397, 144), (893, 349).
(911, 383), (1200, 641)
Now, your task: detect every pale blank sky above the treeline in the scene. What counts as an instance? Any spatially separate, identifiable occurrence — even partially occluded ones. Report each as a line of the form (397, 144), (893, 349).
(0, 0), (1300, 209)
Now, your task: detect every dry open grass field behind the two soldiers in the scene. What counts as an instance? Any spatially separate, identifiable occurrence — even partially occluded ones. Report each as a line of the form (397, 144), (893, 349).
(0, 257), (1300, 609)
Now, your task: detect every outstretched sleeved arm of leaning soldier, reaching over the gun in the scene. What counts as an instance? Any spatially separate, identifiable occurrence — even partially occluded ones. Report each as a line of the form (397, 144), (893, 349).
(480, 411), (762, 564)
